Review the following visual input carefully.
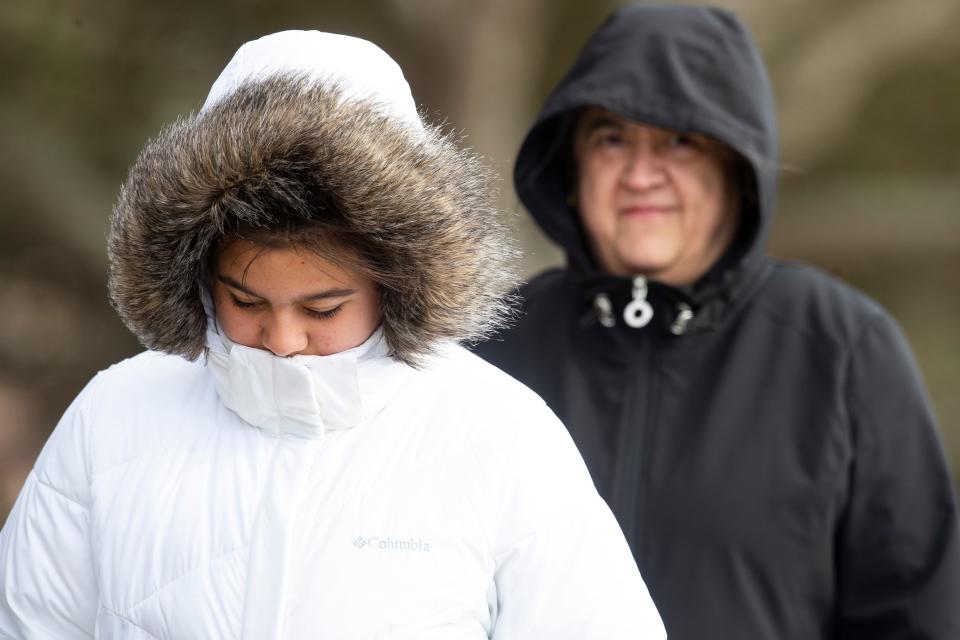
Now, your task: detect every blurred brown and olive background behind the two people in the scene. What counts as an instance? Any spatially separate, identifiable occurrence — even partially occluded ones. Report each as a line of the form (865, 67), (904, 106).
(0, 0), (960, 521)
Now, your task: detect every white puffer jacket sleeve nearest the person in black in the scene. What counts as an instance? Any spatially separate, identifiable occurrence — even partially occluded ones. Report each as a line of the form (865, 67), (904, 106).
(492, 407), (666, 640)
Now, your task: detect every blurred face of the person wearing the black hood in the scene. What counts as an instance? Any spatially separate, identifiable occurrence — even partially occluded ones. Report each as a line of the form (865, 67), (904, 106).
(574, 108), (740, 286)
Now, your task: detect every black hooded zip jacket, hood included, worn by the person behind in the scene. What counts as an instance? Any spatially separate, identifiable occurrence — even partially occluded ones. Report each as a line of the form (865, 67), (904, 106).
(478, 6), (960, 640)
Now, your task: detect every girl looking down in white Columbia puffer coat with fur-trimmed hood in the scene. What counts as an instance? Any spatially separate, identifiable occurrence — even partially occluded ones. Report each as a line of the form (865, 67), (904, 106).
(0, 32), (664, 640)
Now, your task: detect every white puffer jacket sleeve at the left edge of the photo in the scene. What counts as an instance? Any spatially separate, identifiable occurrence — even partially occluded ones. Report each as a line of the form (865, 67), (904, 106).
(0, 386), (98, 640)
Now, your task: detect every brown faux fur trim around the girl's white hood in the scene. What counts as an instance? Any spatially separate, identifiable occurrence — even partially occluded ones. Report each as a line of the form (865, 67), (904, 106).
(108, 75), (516, 365)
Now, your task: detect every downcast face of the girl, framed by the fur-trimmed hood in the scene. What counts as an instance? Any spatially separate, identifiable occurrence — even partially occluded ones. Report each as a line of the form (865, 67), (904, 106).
(213, 240), (382, 357)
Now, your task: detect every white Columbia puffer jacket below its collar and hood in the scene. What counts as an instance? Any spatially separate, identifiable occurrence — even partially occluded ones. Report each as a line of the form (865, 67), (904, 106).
(0, 334), (664, 640)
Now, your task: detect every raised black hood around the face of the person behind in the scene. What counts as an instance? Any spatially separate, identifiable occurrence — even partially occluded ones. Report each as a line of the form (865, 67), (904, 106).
(514, 6), (777, 276)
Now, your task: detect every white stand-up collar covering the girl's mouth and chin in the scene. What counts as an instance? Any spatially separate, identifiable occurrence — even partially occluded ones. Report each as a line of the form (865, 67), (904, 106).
(207, 288), (409, 438)
